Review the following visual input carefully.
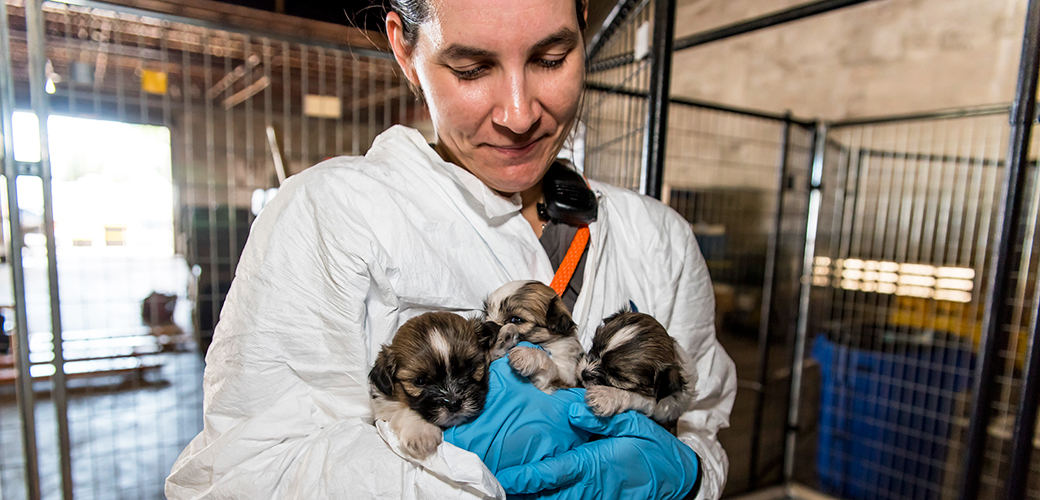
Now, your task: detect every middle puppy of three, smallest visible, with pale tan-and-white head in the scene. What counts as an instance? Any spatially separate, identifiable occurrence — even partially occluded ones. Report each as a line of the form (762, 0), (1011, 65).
(484, 281), (582, 393)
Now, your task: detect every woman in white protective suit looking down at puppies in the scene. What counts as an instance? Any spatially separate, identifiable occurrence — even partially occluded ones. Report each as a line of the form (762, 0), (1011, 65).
(166, 0), (736, 499)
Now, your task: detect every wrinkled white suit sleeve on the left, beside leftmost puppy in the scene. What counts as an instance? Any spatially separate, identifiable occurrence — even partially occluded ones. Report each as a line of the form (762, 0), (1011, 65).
(165, 167), (499, 500)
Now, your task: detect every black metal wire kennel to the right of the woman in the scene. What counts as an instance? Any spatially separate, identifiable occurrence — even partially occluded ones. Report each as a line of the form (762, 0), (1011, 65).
(584, 1), (1040, 499)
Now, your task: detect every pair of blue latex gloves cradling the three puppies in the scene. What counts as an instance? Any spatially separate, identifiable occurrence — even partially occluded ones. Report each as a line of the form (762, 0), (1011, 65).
(444, 342), (699, 500)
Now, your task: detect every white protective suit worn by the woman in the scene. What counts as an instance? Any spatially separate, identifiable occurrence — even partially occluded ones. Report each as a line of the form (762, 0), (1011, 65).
(165, 126), (736, 500)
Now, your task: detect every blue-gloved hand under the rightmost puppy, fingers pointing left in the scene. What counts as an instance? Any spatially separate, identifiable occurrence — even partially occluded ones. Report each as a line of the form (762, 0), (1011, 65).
(495, 403), (700, 500)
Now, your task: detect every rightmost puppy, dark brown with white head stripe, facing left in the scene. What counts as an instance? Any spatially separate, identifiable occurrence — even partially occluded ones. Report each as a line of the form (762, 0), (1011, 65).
(580, 310), (697, 427)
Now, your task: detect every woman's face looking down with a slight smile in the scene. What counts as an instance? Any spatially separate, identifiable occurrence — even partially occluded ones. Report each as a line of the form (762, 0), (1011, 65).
(387, 0), (584, 193)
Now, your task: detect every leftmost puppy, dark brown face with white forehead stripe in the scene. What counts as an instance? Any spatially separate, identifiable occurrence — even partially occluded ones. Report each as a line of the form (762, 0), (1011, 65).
(368, 312), (496, 459)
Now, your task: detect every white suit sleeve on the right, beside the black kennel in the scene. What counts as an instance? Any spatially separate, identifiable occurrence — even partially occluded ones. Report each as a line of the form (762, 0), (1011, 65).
(657, 208), (736, 500)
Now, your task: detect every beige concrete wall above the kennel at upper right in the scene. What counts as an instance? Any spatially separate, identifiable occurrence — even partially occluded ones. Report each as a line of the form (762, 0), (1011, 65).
(672, 0), (1026, 120)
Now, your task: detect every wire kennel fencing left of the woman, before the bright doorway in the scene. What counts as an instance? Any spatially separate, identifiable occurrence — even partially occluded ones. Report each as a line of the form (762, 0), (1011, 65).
(0, 0), (424, 494)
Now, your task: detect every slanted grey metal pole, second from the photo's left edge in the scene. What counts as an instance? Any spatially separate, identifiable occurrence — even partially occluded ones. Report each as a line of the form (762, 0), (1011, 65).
(25, 0), (72, 500)
